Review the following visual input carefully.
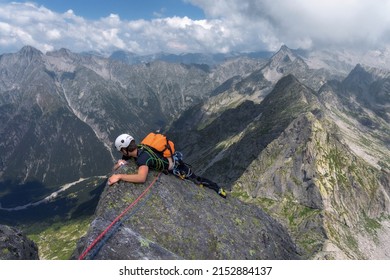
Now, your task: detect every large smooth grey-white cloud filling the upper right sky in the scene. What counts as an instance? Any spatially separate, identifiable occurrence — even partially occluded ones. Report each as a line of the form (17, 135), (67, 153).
(188, 0), (390, 48)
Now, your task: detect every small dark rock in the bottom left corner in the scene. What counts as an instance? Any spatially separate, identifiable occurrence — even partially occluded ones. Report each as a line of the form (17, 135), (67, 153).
(0, 225), (39, 260)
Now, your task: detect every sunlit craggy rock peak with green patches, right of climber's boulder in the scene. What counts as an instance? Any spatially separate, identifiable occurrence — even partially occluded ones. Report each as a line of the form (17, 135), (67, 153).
(233, 112), (390, 259)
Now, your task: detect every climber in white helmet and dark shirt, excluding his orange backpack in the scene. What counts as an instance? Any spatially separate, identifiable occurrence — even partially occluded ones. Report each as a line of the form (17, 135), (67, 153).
(108, 134), (226, 198)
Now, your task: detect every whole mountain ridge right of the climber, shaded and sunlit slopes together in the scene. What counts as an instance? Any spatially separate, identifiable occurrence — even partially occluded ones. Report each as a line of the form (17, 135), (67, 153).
(171, 48), (390, 259)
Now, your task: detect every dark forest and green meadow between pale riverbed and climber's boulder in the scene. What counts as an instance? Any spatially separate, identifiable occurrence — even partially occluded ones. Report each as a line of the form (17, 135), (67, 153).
(0, 177), (105, 260)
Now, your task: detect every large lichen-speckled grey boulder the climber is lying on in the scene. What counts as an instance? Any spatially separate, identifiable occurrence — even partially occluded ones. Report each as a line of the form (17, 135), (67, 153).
(74, 163), (300, 259)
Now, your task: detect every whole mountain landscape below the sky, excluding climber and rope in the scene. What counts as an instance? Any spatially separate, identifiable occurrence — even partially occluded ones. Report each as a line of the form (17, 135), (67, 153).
(0, 46), (390, 259)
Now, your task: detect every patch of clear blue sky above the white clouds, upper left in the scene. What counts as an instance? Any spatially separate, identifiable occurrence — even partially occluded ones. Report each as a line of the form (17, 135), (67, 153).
(30, 0), (204, 20)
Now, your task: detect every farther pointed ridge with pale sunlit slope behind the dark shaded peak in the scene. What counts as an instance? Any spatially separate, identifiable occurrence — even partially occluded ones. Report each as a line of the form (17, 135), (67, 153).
(170, 46), (345, 133)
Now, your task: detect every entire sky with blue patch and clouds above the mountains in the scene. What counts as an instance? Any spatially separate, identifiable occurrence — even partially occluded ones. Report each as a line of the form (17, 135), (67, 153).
(0, 0), (390, 55)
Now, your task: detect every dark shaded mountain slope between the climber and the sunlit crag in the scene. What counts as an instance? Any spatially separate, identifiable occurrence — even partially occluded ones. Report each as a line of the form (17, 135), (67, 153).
(171, 74), (319, 185)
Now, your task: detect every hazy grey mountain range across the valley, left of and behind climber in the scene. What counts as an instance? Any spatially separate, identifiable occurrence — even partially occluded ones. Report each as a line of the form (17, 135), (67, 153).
(0, 46), (266, 208)
